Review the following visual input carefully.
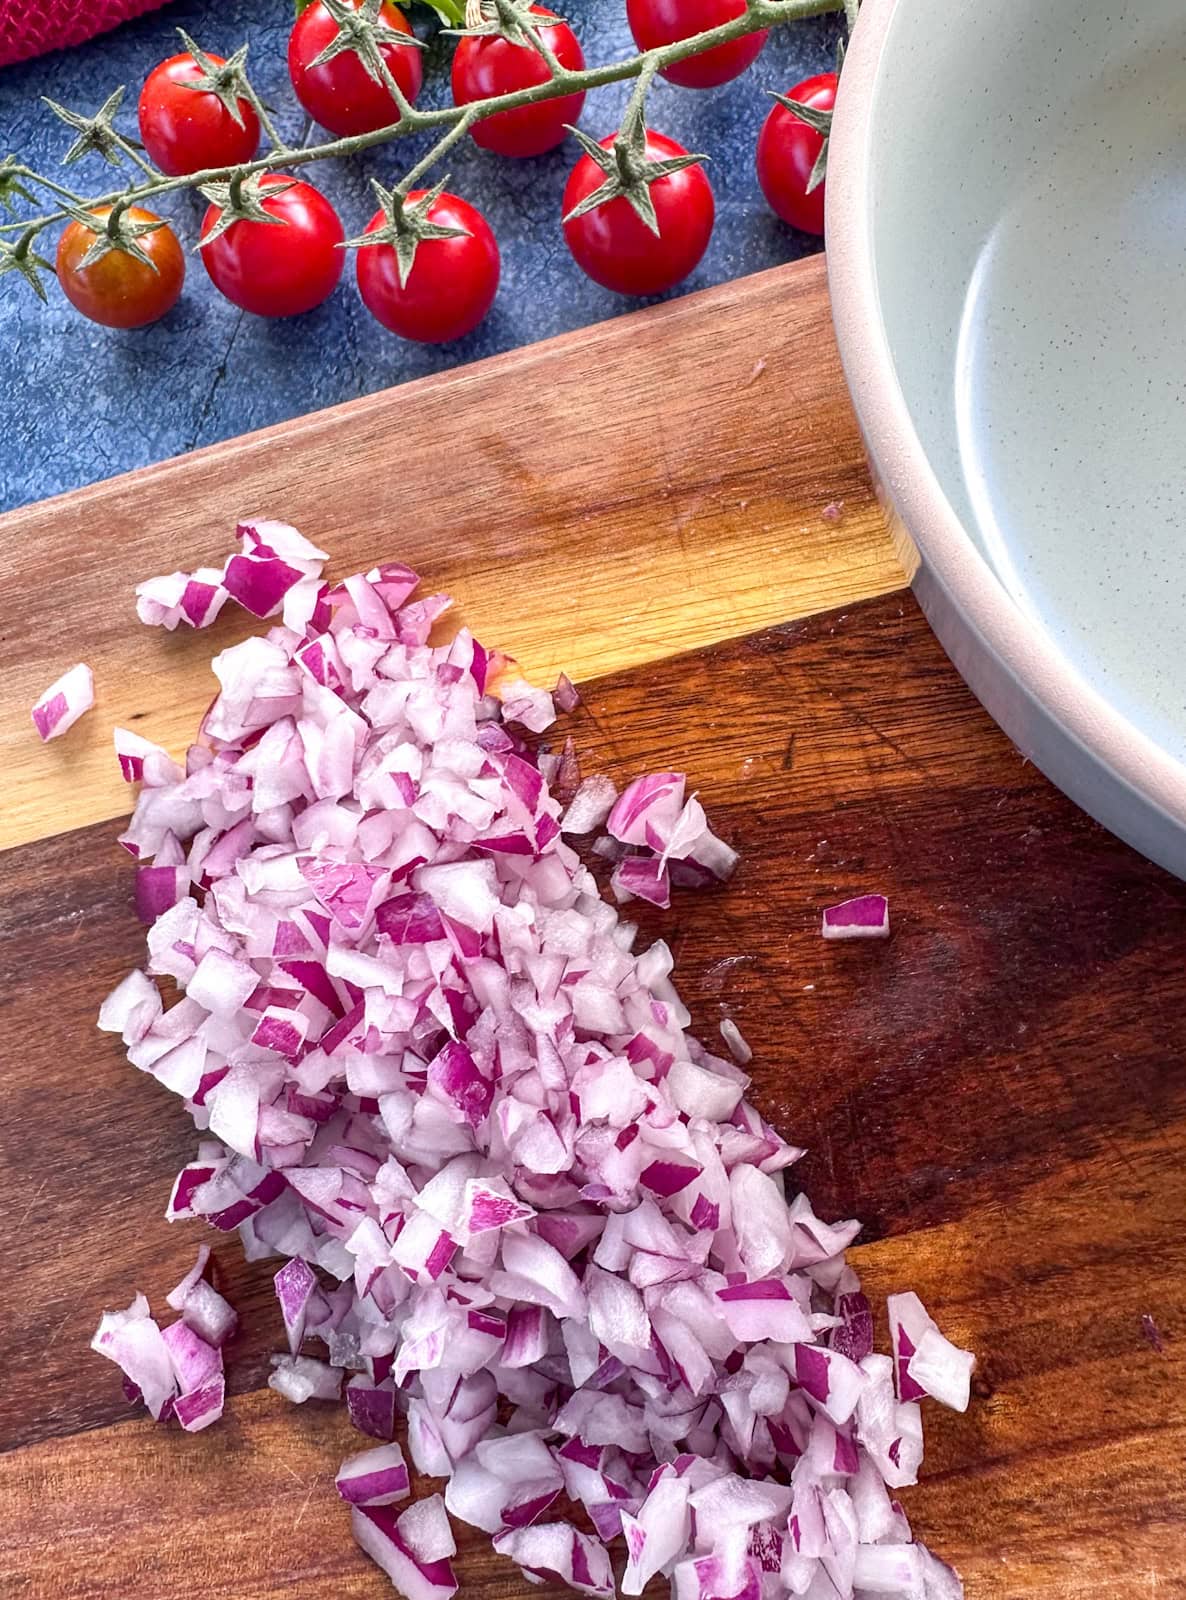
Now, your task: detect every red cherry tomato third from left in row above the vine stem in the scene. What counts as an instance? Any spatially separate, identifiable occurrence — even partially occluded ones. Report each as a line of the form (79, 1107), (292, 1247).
(453, 5), (584, 155)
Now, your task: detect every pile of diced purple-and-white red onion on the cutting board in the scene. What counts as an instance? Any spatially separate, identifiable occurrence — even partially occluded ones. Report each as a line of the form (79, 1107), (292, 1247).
(94, 522), (972, 1600)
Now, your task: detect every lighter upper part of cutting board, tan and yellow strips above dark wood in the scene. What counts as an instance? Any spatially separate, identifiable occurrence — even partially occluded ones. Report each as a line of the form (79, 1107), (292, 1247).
(0, 258), (901, 848)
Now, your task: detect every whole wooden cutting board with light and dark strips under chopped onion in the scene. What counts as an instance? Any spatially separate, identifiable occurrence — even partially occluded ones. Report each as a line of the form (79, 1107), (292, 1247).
(0, 262), (1186, 1600)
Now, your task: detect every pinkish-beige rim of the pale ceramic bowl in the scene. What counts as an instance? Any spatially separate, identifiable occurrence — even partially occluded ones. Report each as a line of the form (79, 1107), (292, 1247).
(826, 0), (1186, 830)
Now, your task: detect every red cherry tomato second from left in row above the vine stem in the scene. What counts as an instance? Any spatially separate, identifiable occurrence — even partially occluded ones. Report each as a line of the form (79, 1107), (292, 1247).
(288, 0), (424, 139)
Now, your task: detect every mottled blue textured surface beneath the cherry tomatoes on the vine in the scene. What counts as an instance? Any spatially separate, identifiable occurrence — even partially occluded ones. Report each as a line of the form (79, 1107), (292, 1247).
(0, 0), (839, 509)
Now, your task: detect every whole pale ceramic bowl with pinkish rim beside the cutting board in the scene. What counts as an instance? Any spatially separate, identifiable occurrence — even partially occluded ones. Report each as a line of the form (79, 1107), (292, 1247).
(827, 0), (1186, 877)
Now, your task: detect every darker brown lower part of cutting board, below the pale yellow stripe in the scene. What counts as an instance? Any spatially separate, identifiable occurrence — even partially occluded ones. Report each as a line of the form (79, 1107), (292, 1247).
(0, 595), (1186, 1600)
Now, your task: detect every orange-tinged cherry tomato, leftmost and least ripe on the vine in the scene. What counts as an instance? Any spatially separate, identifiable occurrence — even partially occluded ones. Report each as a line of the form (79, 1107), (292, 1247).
(58, 206), (186, 328)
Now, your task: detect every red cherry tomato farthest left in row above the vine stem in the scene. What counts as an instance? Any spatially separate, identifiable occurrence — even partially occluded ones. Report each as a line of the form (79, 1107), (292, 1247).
(139, 53), (259, 178)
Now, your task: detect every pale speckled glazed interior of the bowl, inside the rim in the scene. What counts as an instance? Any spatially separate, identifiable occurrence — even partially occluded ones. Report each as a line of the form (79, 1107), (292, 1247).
(857, 0), (1186, 760)
